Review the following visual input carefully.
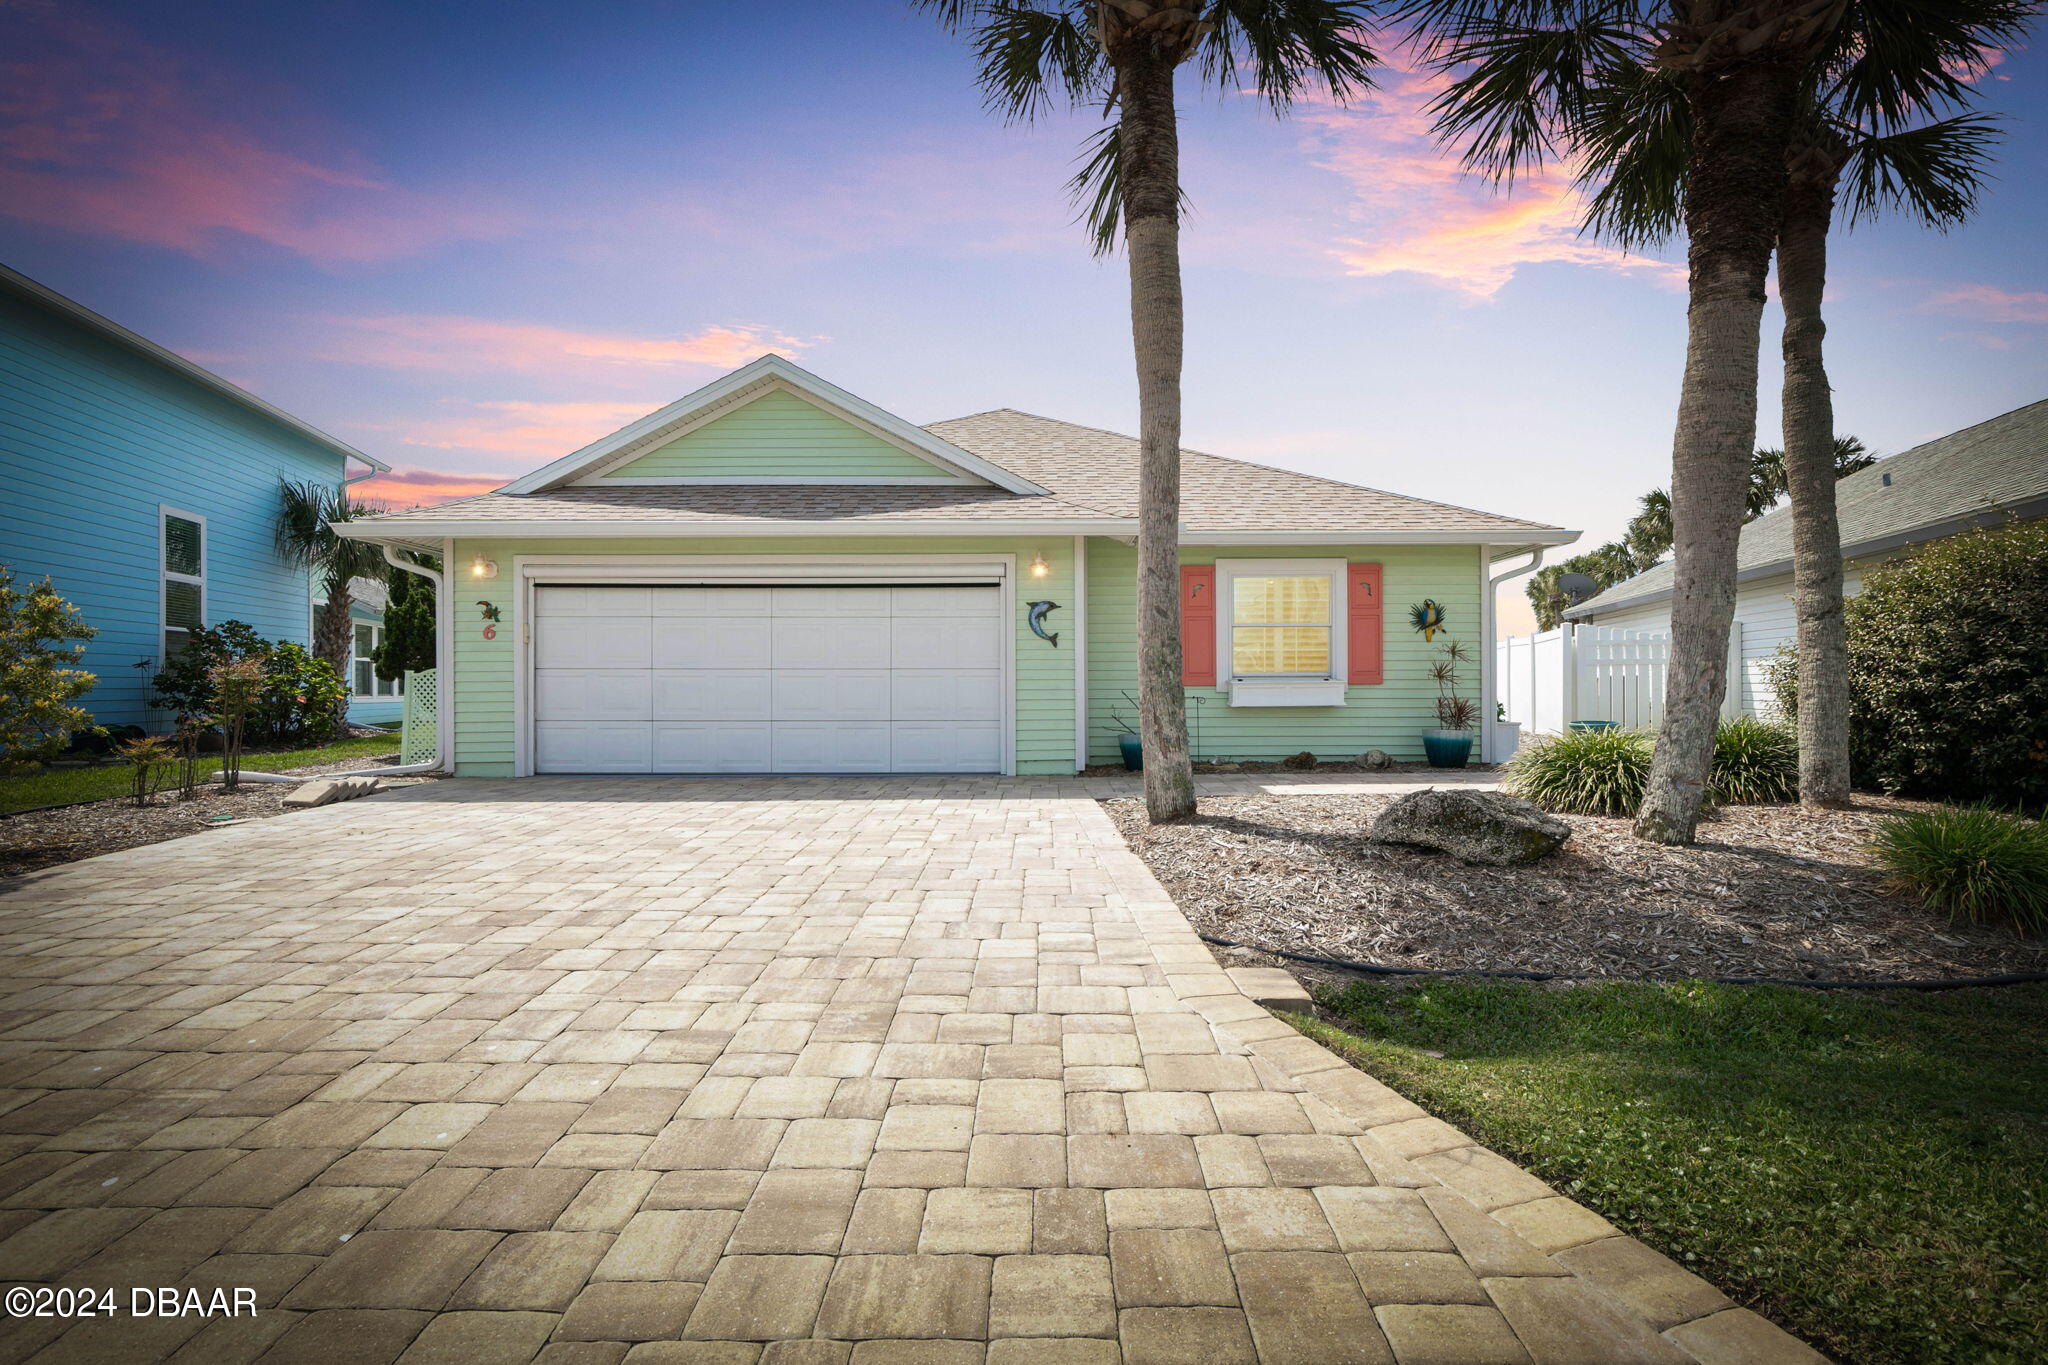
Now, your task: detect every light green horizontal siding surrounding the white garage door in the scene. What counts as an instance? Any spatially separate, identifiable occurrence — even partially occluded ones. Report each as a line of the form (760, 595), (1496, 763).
(451, 536), (1073, 776)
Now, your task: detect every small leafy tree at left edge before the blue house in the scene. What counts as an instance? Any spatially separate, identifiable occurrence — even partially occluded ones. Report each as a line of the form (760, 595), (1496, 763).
(0, 567), (98, 767)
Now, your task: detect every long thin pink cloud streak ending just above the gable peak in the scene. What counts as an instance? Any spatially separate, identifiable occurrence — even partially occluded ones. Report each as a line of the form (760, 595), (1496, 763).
(324, 313), (809, 379)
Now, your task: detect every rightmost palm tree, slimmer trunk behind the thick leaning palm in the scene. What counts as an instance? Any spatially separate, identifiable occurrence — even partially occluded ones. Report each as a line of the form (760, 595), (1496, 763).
(1577, 0), (2036, 806)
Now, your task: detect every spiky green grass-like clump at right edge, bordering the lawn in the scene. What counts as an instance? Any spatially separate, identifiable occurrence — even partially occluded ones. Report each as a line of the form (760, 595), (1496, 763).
(1870, 806), (2048, 933)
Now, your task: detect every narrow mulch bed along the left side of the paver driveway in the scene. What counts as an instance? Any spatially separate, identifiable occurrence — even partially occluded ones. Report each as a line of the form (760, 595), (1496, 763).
(0, 753), (430, 878)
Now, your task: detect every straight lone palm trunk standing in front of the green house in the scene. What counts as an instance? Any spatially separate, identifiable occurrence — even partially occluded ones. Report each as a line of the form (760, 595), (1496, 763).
(1116, 43), (1194, 825)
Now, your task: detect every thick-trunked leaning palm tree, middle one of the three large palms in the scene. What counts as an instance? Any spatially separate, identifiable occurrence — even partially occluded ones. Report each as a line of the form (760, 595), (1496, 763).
(1405, 0), (1990, 843)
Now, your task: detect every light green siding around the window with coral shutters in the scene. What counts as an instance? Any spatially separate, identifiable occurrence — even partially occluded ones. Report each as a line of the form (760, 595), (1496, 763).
(1087, 538), (1481, 763)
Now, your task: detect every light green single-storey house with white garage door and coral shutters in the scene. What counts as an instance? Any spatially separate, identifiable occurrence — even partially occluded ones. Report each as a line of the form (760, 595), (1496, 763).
(338, 356), (1577, 776)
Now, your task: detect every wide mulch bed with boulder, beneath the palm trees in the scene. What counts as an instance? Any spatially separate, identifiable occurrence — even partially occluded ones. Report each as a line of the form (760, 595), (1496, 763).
(1104, 796), (2048, 980)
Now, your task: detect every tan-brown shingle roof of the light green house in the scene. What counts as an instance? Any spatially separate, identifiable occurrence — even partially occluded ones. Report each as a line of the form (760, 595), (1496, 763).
(352, 407), (1561, 542)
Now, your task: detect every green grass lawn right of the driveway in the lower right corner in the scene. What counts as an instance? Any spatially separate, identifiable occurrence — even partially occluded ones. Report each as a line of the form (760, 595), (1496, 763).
(1303, 980), (2048, 1363)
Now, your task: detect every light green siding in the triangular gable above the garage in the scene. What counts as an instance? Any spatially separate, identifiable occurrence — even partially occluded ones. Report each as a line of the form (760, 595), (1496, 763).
(608, 389), (946, 479)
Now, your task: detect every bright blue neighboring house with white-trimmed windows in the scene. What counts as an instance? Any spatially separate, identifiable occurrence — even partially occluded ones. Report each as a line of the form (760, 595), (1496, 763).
(0, 266), (399, 729)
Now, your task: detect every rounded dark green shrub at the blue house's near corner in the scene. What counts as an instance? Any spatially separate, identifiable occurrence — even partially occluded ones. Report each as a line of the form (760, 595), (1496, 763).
(152, 620), (346, 745)
